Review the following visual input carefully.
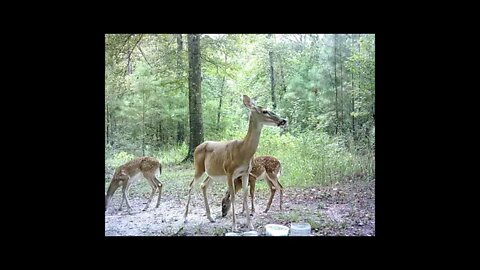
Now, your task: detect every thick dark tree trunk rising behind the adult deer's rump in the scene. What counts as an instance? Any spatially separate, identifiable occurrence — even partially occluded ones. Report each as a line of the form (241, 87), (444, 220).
(184, 34), (203, 161)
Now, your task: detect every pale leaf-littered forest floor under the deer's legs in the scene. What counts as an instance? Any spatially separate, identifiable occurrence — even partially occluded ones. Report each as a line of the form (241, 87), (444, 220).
(105, 162), (375, 236)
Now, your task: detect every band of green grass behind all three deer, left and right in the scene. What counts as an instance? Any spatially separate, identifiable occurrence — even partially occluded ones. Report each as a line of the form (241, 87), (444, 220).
(105, 128), (375, 194)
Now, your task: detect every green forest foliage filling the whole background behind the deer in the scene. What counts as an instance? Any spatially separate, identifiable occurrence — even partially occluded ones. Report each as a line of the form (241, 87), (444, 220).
(105, 34), (375, 186)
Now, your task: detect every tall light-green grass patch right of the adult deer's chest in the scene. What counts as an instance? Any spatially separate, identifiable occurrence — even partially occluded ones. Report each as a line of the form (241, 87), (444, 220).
(256, 129), (375, 186)
